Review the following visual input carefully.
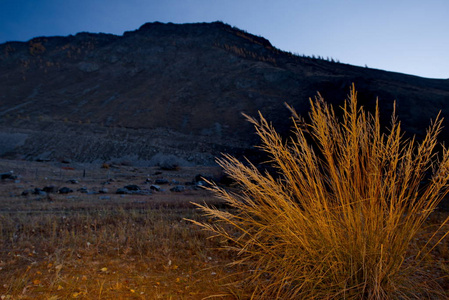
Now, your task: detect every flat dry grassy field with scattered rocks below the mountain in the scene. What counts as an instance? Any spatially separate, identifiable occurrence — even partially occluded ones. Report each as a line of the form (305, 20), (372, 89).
(0, 160), (449, 300)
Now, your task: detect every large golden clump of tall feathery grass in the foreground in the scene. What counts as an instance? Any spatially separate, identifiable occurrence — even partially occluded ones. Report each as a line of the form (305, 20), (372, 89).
(197, 87), (449, 299)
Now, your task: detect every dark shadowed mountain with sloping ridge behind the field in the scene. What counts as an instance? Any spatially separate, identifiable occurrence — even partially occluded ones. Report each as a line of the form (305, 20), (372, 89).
(0, 22), (449, 164)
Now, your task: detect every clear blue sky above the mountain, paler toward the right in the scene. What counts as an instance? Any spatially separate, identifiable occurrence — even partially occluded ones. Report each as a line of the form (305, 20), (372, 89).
(0, 0), (449, 78)
